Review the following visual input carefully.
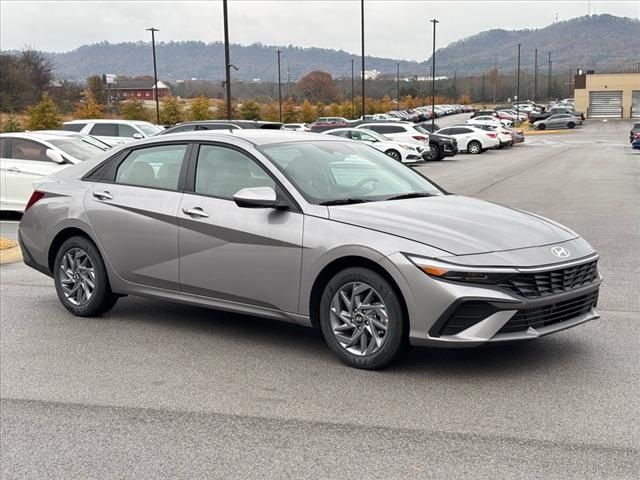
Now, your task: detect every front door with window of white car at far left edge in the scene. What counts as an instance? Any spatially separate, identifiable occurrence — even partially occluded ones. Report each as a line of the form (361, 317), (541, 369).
(2, 137), (64, 211)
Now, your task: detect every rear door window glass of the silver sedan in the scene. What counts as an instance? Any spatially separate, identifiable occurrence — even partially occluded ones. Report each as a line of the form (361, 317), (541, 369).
(115, 145), (187, 190)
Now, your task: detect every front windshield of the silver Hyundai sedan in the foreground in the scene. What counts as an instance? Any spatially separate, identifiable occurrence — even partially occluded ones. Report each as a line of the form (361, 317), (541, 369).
(261, 140), (443, 204)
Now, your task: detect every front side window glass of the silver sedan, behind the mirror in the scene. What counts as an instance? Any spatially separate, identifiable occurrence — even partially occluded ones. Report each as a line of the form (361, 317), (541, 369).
(195, 145), (275, 200)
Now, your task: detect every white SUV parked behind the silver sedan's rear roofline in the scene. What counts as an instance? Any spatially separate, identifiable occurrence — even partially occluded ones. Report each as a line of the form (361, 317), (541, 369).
(62, 120), (163, 146)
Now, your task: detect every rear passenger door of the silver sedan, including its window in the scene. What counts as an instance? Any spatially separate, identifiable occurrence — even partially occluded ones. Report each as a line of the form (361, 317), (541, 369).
(84, 142), (190, 291)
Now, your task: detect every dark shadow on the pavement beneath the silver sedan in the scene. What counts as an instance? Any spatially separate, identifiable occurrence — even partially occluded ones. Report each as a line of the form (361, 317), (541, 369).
(104, 297), (590, 377)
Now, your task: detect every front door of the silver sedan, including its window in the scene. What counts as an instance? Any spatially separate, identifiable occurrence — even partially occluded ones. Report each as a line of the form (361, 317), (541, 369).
(178, 144), (304, 312)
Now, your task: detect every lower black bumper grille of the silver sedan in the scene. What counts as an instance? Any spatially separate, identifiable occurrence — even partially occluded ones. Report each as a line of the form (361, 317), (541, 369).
(498, 291), (598, 333)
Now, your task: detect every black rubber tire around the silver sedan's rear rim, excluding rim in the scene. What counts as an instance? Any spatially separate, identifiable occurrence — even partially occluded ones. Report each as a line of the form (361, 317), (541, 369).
(53, 237), (118, 317)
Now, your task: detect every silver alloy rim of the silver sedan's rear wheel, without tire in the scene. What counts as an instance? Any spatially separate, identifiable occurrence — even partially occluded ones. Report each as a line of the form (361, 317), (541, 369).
(58, 248), (96, 306)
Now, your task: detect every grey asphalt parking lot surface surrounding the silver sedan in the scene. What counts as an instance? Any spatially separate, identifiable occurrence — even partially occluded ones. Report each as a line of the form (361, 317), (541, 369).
(0, 121), (640, 480)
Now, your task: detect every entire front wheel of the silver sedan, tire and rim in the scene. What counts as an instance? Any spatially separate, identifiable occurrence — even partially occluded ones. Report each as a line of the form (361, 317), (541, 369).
(319, 267), (408, 370)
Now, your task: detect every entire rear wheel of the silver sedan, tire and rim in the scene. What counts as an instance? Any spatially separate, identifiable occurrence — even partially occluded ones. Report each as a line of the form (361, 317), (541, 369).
(53, 237), (118, 317)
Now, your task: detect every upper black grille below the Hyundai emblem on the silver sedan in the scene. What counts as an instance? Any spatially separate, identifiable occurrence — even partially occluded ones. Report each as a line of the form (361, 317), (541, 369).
(499, 260), (598, 298)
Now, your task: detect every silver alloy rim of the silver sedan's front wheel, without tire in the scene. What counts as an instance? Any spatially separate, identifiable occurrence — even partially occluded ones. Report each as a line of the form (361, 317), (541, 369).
(329, 282), (389, 356)
